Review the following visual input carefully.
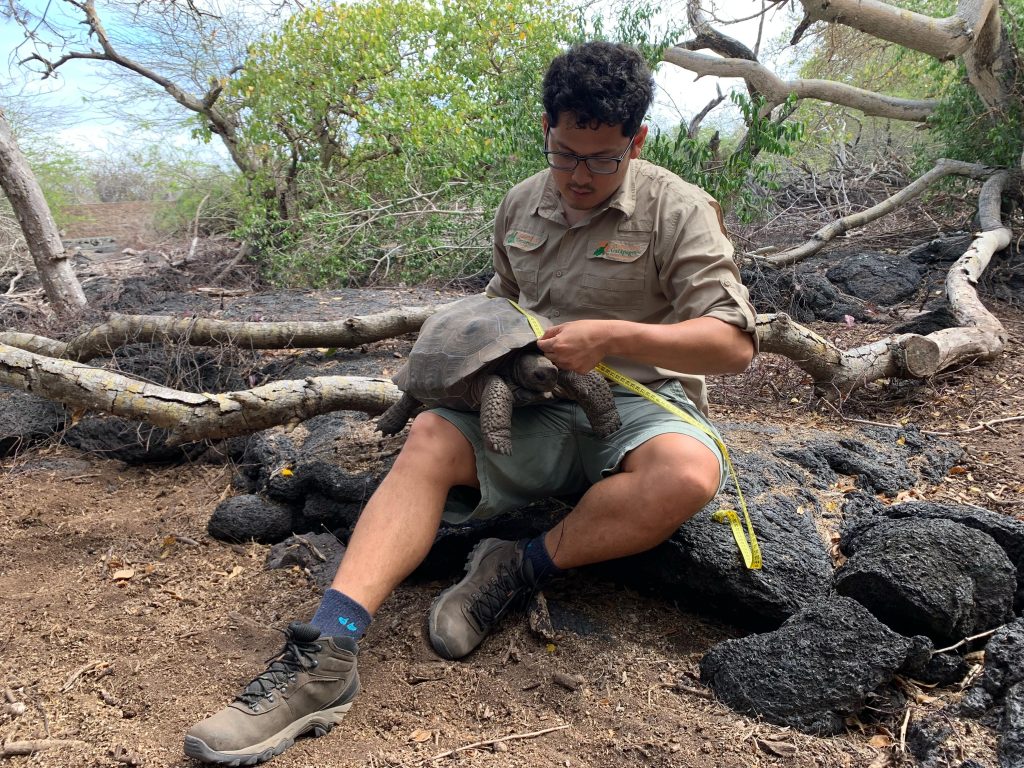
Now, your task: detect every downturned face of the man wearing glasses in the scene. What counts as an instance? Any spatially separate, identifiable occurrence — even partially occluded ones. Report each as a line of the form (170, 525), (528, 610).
(543, 113), (647, 211)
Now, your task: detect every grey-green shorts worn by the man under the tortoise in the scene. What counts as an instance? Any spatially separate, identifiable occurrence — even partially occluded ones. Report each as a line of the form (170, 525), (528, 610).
(433, 379), (727, 523)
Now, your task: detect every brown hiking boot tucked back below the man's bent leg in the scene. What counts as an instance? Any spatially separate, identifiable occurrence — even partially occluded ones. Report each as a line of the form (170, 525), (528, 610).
(429, 539), (538, 658)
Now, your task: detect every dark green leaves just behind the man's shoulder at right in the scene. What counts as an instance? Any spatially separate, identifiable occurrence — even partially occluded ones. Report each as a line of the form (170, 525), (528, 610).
(644, 91), (804, 221)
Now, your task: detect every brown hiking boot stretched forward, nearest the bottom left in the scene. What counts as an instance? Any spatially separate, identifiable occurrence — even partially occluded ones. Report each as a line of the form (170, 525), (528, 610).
(185, 622), (359, 766)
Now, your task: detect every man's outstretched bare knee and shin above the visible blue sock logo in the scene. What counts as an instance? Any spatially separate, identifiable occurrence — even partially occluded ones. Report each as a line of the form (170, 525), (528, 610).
(331, 412), (478, 614)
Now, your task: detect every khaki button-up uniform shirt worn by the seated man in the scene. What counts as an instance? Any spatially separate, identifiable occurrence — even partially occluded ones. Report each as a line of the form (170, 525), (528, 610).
(486, 160), (757, 413)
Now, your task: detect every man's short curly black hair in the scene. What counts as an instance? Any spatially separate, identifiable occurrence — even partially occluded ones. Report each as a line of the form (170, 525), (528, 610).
(544, 40), (654, 136)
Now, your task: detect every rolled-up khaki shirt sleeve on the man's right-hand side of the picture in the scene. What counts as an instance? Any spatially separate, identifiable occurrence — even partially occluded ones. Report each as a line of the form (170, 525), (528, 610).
(655, 193), (758, 349)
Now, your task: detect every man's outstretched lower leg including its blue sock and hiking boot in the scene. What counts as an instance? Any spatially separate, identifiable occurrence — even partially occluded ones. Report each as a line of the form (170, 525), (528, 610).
(184, 413), (477, 765)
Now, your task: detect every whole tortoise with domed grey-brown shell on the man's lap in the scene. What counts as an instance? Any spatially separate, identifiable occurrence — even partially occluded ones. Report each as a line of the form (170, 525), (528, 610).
(377, 296), (622, 456)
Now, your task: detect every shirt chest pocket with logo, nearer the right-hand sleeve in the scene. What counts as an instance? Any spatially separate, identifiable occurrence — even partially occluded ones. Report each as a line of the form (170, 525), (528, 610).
(580, 232), (650, 309)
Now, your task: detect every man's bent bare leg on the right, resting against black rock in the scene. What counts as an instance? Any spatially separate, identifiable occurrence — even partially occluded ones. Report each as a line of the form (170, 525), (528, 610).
(544, 434), (721, 568)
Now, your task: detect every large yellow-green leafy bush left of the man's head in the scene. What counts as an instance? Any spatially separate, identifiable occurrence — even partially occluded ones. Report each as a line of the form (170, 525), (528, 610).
(225, 0), (570, 286)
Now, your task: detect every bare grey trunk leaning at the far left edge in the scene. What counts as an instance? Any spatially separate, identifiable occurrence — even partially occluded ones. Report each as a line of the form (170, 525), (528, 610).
(0, 111), (87, 314)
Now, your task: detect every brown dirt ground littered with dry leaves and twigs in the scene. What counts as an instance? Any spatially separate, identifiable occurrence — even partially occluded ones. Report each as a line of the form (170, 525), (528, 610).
(0, 241), (1024, 768)
